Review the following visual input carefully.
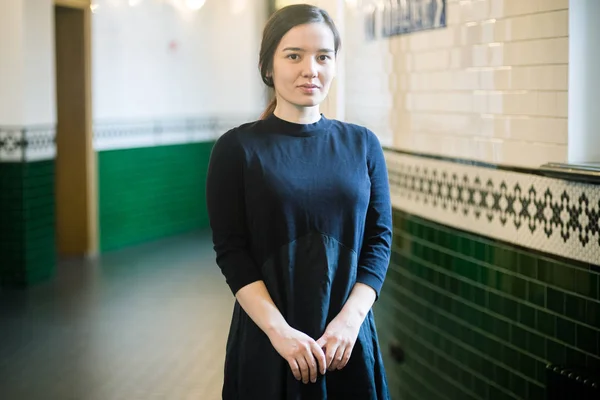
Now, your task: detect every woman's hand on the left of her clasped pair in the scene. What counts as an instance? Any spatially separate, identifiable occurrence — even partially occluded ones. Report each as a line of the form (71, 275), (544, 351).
(269, 326), (325, 383)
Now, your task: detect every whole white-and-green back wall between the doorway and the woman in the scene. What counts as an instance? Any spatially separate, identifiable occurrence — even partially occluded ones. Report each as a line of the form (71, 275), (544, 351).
(92, 0), (266, 251)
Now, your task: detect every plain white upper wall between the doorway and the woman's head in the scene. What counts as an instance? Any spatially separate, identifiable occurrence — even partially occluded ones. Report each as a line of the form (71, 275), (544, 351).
(92, 0), (265, 121)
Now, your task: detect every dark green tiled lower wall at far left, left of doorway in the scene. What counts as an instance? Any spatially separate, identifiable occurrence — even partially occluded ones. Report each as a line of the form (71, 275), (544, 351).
(0, 160), (56, 287)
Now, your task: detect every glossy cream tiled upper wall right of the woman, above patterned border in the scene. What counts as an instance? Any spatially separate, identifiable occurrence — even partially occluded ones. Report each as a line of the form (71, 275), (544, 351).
(344, 0), (568, 167)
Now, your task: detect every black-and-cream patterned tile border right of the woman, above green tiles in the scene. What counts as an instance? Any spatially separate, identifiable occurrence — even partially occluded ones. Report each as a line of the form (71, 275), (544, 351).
(385, 150), (600, 265)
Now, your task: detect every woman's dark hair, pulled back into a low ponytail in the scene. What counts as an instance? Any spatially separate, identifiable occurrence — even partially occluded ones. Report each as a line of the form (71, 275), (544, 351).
(258, 4), (342, 119)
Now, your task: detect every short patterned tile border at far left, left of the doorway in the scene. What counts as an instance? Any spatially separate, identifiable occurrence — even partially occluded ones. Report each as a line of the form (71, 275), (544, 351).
(0, 125), (56, 163)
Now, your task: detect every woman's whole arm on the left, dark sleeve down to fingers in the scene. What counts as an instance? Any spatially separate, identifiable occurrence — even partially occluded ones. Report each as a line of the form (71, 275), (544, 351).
(206, 131), (325, 383)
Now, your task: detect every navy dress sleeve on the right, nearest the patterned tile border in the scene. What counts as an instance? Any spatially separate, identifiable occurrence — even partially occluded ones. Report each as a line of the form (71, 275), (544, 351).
(356, 131), (392, 297)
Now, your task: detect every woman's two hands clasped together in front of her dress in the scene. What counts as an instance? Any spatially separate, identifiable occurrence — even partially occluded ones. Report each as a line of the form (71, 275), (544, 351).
(270, 315), (361, 383)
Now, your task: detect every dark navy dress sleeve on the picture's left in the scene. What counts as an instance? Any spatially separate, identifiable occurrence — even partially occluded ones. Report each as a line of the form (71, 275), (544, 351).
(206, 130), (262, 295)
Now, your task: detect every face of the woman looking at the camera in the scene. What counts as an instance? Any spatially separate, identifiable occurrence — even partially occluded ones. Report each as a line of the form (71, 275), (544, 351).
(272, 23), (335, 111)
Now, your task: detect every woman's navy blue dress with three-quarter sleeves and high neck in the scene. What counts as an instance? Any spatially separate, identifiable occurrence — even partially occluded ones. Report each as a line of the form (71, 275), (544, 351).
(206, 115), (392, 400)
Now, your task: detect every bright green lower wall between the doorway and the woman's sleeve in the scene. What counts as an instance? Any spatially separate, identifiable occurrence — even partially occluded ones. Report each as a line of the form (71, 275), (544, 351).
(98, 142), (214, 251)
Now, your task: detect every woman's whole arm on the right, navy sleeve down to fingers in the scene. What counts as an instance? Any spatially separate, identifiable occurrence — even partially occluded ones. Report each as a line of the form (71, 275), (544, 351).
(317, 131), (392, 370)
